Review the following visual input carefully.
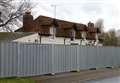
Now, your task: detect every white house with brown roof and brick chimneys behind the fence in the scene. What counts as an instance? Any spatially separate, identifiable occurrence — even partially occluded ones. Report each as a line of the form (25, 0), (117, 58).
(13, 12), (101, 46)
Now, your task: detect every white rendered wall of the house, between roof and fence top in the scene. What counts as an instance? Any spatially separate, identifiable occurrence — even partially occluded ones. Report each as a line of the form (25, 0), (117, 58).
(13, 33), (101, 46)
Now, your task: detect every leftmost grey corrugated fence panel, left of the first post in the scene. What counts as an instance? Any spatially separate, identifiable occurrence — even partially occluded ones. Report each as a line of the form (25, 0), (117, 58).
(0, 43), (18, 77)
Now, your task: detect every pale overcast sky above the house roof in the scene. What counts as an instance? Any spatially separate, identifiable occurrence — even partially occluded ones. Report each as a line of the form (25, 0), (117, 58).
(23, 0), (120, 30)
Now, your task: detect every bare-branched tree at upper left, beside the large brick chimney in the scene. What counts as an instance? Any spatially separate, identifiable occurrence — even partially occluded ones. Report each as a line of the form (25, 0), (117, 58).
(0, 0), (32, 32)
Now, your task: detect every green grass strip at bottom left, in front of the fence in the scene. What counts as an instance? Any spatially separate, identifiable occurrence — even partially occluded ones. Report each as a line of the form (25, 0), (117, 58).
(0, 78), (35, 83)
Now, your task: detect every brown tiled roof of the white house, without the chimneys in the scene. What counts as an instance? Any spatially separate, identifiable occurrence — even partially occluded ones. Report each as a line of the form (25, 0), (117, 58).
(16, 16), (98, 39)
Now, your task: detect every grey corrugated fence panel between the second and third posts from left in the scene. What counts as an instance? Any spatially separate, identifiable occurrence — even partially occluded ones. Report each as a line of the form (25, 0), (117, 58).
(54, 45), (77, 72)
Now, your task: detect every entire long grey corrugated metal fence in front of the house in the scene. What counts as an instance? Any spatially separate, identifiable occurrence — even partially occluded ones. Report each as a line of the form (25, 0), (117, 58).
(0, 43), (120, 77)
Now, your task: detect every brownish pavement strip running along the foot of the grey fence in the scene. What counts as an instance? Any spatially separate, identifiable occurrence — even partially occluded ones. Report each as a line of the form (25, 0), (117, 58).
(32, 68), (120, 83)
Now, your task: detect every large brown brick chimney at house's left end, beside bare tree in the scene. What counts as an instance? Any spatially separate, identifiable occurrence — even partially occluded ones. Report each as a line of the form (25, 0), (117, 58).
(23, 11), (34, 32)
